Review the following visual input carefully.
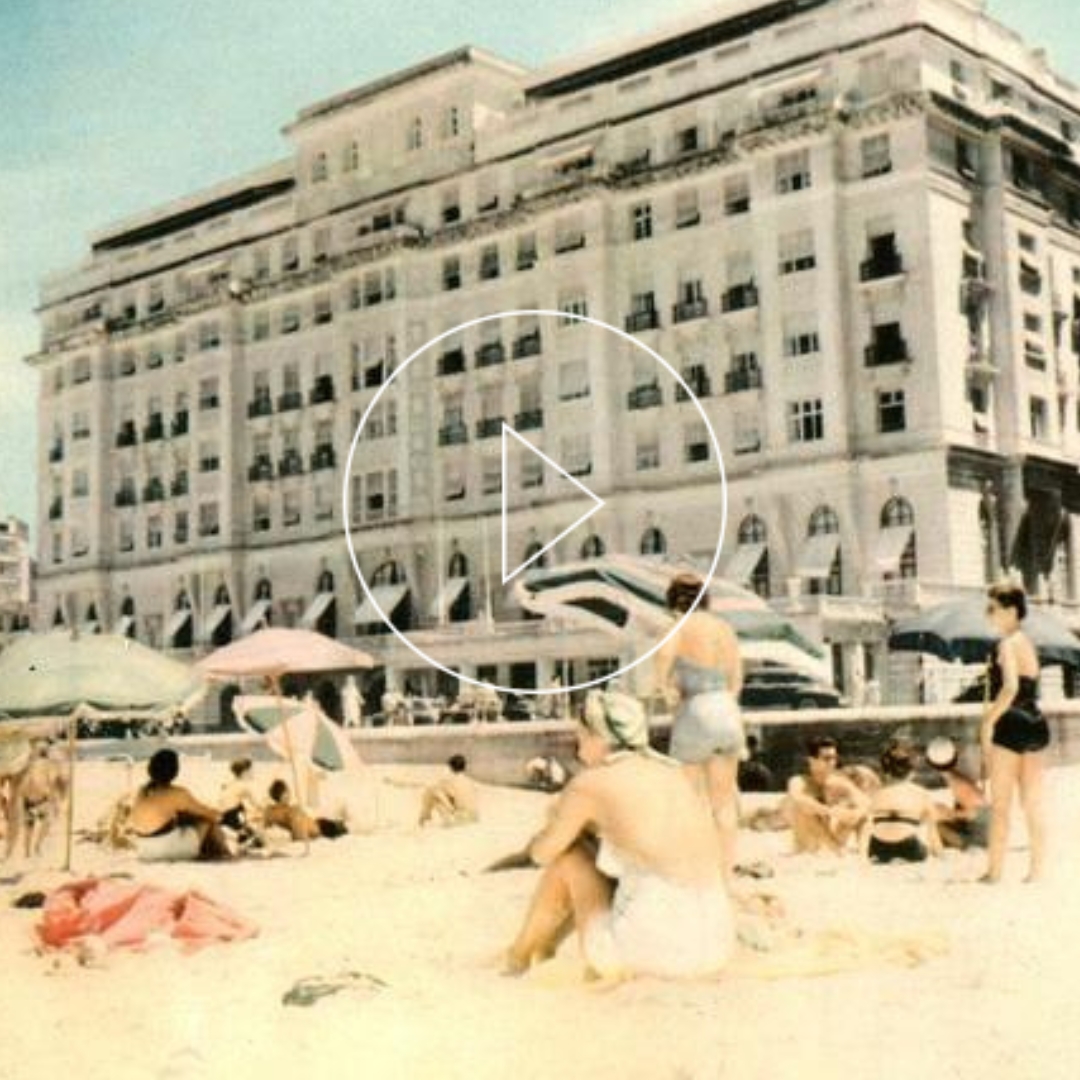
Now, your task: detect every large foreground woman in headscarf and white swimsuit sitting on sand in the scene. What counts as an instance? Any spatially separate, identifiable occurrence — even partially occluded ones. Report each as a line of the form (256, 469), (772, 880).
(507, 691), (734, 976)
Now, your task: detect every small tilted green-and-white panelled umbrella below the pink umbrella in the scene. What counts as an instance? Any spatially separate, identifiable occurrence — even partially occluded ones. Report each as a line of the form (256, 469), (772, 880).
(232, 694), (363, 772)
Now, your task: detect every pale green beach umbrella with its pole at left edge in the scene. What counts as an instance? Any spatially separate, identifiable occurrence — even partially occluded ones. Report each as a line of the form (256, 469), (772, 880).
(0, 631), (204, 869)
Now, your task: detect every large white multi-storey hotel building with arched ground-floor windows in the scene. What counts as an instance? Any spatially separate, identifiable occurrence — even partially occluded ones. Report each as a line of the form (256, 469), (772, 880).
(23, 0), (1080, 697)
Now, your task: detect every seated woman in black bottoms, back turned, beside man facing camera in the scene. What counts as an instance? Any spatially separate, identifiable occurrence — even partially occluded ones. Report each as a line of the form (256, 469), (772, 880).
(865, 743), (942, 863)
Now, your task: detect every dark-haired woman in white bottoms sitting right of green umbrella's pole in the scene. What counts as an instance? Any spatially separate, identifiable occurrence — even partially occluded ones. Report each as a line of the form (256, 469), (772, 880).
(130, 748), (231, 862)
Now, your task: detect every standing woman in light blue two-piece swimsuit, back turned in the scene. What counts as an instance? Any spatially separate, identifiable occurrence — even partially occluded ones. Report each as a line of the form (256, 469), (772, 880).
(656, 573), (746, 876)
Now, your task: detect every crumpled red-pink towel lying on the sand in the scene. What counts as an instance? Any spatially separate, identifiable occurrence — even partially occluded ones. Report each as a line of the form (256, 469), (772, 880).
(37, 878), (258, 948)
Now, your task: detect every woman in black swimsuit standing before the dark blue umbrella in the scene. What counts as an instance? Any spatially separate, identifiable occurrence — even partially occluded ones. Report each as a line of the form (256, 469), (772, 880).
(980, 585), (1050, 883)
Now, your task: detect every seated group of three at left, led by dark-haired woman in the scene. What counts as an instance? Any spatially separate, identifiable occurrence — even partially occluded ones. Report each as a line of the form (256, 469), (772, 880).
(127, 746), (348, 862)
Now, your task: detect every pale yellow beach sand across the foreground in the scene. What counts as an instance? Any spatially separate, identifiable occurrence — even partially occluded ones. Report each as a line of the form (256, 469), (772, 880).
(0, 761), (1080, 1080)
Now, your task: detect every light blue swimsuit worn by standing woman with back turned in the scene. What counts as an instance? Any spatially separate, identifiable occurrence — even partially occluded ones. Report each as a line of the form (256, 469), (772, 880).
(671, 657), (746, 765)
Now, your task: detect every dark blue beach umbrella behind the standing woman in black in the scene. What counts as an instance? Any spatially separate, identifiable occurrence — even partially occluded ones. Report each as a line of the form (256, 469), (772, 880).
(889, 597), (1080, 667)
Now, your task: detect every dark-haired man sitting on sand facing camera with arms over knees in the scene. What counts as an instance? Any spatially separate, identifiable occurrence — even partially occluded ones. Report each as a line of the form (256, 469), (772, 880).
(784, 735), (869, 854)
